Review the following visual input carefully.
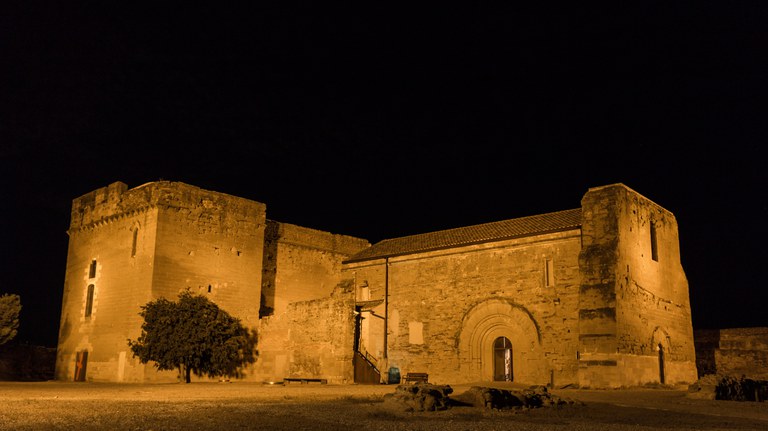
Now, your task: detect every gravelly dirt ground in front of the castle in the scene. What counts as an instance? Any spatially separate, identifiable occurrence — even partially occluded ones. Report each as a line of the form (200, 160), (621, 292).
(0, 382), (768, 431)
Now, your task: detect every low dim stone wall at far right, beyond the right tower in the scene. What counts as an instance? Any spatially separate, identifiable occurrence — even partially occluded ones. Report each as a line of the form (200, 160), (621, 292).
(694, 328), (768, 380)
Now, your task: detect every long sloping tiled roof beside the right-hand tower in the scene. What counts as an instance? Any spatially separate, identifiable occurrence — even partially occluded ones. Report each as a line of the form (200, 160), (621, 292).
(346, 208), (581, 262)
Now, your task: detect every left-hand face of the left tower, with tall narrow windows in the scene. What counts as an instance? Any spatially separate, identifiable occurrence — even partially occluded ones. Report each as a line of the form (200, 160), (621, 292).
(56, 183), (157, 381)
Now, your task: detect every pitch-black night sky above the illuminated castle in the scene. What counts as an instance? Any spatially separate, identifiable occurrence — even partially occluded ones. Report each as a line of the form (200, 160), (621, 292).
(0, 1), (768, 346)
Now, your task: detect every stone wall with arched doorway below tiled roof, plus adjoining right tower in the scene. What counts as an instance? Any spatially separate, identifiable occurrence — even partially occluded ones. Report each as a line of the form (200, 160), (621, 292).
(345, 184), (696, 387)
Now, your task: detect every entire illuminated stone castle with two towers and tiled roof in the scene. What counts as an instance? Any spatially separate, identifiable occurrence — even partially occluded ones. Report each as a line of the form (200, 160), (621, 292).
(56, 181), (697, 387)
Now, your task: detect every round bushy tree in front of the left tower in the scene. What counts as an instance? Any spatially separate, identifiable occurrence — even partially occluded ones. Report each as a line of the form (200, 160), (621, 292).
(128, 291), (257, 383)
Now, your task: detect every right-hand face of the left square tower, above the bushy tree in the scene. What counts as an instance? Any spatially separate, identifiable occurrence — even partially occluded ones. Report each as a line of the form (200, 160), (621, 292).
(152, 183), (266, 328)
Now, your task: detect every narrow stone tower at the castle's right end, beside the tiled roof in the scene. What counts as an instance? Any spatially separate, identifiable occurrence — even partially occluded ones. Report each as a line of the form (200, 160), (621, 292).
(579, 184), (696, 387)
